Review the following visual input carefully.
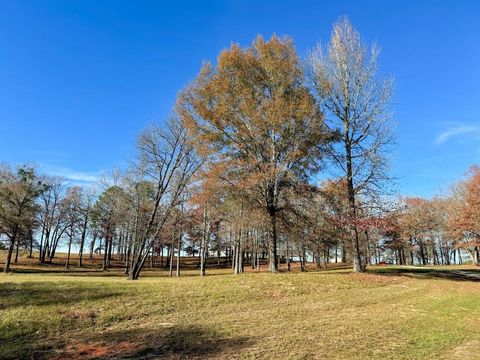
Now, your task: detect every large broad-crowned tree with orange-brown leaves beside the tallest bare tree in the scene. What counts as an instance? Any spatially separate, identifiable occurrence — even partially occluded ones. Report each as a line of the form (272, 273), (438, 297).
(178, 36), (331, 272)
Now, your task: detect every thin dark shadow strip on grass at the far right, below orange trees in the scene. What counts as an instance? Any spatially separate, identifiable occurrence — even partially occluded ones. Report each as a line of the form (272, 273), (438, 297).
(368, 267), (480, 282)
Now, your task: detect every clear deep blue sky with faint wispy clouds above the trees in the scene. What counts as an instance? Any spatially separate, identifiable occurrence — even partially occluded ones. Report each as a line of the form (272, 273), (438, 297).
(0, 0), (480, 196)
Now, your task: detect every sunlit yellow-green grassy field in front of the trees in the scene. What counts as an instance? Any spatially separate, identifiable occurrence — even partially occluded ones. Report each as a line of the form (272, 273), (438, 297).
(0, 260), (480, 359)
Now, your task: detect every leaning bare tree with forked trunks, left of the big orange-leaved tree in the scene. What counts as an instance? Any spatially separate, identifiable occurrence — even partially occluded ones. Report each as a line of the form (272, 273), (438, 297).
(128, 117), (201, 280)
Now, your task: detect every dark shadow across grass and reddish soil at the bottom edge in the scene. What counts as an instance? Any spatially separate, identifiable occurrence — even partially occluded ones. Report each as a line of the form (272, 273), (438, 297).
(46, 324), (253, 360)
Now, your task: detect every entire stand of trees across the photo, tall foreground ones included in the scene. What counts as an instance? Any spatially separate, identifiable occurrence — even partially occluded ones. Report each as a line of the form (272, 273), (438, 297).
(0, 18), (478, 280)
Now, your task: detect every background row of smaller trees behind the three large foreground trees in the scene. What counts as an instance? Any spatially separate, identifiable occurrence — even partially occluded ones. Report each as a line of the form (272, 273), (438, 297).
(0, 162), (480, 275)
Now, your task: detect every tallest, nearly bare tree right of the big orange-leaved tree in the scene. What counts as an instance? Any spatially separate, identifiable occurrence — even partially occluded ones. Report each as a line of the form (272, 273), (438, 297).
(310, 17), (393, 272)
